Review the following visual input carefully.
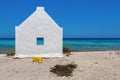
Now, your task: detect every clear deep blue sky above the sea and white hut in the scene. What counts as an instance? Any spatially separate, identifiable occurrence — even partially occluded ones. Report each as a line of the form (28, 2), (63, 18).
(0, 0), (120, 38)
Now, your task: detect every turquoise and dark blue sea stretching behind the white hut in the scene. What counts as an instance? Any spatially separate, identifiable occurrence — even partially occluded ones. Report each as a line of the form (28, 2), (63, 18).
(0, 38), (120, 53)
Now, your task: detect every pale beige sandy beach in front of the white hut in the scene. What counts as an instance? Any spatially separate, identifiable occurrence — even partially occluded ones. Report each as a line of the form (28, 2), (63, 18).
(0, 51), (120, 80)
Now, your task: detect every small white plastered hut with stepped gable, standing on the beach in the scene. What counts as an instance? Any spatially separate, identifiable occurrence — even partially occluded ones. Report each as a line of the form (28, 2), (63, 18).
(14, 7), (63, 58)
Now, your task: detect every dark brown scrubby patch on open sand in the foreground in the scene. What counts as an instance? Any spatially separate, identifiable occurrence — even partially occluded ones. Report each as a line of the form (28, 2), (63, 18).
(50, 63), (77, 77)
